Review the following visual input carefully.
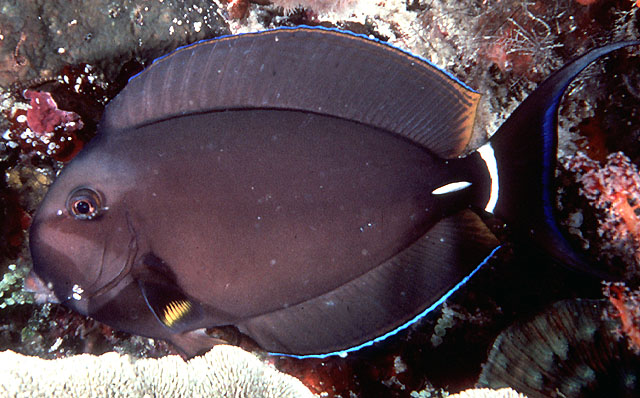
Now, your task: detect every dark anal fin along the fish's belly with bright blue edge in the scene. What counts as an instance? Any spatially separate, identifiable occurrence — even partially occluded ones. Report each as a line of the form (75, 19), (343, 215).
(237, 210), (498, 357)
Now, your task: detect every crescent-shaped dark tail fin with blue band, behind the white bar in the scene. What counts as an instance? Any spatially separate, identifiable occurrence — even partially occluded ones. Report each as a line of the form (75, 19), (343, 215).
(489, 42), (640, 277)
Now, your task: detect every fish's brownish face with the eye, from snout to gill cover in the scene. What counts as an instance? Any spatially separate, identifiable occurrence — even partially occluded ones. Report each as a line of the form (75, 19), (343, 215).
(27, 146), (144, 315)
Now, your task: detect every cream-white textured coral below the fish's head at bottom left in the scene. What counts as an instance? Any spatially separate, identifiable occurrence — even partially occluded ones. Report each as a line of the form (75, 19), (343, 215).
(0, 345), (314, 398)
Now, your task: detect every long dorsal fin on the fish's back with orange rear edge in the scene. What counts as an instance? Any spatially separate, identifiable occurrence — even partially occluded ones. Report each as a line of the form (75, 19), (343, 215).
(101, 27), (480, 158)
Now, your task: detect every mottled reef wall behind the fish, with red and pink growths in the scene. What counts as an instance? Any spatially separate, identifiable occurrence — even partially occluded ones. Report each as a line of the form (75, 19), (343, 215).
(0, 0), (640, 397)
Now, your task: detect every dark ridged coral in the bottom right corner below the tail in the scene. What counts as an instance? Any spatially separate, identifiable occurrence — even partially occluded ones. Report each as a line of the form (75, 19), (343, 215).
(477, 299), (640, 398)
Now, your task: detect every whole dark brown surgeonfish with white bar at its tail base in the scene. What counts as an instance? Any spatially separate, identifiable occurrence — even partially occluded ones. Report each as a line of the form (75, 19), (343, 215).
(28, 28), (632, 356)
